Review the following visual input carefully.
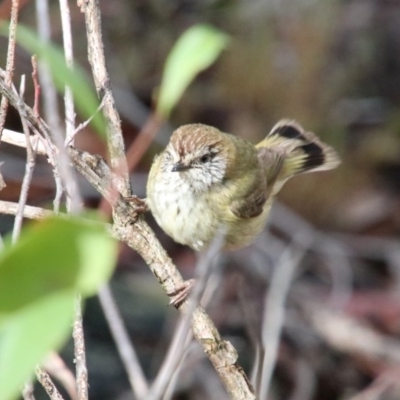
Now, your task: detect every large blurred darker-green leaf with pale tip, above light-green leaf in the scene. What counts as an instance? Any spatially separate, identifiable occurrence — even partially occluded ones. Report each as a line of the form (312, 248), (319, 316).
(0, 218), (116, 317)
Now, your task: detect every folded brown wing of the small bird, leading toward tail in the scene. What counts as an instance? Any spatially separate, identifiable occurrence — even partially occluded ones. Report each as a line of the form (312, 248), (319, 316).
(230, 147), (285, 218)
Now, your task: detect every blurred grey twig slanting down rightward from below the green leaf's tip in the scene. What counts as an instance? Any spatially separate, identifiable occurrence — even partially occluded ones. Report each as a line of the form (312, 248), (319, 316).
(98, 285), (149, 399)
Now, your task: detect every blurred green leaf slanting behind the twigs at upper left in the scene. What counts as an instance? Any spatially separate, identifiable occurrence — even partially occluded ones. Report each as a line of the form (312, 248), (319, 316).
(0, 23), (105, 138)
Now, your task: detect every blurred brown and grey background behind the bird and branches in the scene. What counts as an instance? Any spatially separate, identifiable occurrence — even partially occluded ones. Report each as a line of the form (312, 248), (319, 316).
(0, 0), (400, 400)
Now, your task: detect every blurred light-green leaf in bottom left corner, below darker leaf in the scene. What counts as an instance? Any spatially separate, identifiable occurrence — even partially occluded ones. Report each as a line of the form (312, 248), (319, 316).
(0, 290), (75, 400)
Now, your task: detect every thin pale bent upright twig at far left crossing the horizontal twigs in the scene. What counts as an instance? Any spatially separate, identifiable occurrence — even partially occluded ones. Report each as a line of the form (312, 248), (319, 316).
(12, 76), (36, 243)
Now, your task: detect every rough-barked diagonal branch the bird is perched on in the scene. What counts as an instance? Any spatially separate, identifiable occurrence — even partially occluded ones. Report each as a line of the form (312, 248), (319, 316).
(0, 69), (255, 400)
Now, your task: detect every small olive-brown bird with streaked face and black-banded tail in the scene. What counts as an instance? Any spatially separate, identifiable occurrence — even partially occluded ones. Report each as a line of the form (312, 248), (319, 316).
(147, 120), (340, 250)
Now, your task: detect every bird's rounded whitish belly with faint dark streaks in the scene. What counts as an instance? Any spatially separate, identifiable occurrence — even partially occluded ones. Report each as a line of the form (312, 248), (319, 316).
(149, 179), (217, 250)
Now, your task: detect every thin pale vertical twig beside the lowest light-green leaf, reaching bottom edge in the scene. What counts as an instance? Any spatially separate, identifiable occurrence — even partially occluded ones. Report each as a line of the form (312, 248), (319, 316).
(72, 295), (88, 400)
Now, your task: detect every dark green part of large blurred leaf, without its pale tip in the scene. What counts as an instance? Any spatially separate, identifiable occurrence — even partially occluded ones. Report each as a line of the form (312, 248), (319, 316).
(0, 218), (80, 315)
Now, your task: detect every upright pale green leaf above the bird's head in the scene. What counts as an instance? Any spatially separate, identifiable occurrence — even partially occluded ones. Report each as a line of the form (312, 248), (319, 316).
(156, 25), (229, 118)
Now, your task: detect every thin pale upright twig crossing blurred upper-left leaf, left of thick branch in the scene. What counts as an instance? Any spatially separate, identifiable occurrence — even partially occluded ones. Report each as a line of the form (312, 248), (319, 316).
(59, 0), (75, 145)
